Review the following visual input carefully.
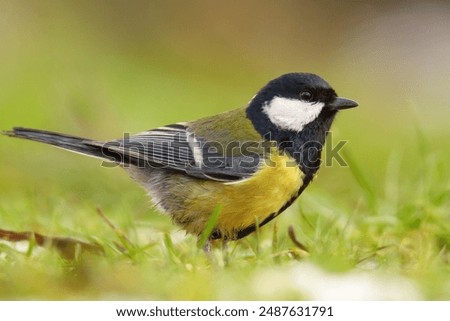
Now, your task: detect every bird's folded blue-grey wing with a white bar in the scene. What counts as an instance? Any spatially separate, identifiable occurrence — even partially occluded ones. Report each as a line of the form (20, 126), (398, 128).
(102, 124), (262, 182)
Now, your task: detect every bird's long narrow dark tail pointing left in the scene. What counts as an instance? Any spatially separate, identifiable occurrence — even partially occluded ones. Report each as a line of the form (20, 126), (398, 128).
(3, 127), (112, 161)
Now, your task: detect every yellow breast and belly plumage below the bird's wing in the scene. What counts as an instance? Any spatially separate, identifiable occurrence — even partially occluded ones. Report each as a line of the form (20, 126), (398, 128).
(185, 152), (303, 238)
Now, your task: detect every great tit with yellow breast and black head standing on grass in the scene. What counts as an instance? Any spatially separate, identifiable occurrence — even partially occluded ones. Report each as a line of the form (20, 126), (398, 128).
(4, 73), (358, 241)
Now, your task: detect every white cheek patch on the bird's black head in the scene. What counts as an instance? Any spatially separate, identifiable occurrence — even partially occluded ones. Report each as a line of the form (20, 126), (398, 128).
(263, 97), (324, 132)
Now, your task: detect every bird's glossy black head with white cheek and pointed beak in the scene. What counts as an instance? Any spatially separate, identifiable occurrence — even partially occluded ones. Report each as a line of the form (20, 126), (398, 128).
(247, 73), (358, 135)
